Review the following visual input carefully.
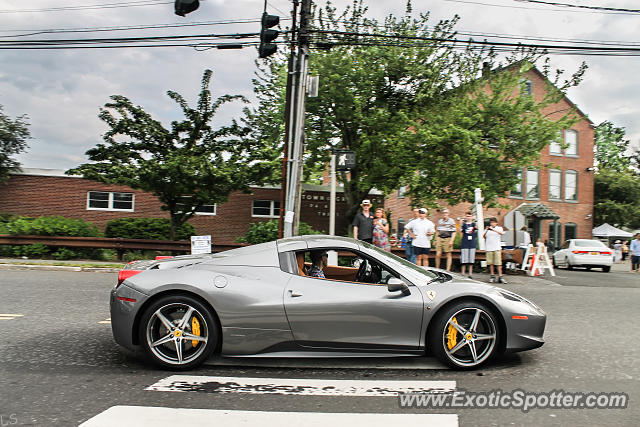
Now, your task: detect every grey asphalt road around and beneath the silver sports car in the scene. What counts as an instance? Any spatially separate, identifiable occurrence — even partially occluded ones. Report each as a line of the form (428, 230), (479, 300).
(0, 270), (640, 427)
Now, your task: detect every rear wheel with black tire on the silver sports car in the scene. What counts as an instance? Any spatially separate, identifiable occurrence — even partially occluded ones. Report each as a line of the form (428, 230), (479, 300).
(138, 295), (220, 370)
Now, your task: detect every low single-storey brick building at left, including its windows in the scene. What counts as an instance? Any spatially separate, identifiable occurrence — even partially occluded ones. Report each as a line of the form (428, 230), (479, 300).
(0, 168), (378, 245)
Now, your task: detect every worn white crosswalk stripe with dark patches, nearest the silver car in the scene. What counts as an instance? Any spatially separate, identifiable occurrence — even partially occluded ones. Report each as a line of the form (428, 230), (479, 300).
(146, 375), (456, 397)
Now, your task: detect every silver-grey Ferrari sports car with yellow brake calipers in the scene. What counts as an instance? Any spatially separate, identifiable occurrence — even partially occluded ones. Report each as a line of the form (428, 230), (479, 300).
(111, 236), (546, 369)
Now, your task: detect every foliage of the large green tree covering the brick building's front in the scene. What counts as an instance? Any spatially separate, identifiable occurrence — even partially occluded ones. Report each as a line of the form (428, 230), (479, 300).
(250, 0), (586, 227)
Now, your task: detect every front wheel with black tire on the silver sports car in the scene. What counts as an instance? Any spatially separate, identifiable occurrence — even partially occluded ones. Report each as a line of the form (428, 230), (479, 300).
(427, 301), (501, 370)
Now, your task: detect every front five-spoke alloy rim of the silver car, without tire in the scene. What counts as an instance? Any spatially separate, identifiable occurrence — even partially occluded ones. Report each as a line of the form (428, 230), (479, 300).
(442, 307), (497, 367)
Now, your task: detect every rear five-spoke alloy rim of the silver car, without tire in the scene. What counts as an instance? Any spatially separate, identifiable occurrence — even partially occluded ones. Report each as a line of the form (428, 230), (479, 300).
(146, 303), (210, 365)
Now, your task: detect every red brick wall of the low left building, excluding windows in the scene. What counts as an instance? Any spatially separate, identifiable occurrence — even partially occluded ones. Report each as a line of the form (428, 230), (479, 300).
(0, 175), (347, 244)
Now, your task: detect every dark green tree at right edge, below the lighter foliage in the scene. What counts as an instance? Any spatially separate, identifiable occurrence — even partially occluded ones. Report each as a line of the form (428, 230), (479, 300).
(594, 169), (640, 229)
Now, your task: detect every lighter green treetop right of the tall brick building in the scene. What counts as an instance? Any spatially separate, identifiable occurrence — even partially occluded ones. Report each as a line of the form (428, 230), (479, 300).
(595, 121), (632, 172)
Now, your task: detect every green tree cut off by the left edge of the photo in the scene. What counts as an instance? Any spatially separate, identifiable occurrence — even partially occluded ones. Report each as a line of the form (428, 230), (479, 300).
(0, 105), (31, 183)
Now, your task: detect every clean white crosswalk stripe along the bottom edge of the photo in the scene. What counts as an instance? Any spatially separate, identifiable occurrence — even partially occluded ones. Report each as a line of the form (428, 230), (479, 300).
(80, 406), (458, 427)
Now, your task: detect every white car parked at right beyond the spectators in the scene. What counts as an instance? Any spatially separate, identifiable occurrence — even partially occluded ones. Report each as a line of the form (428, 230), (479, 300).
(553, 239), (613, 273)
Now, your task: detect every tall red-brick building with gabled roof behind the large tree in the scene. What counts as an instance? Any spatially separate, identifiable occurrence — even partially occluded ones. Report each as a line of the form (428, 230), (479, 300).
(385, 68), (594, 246)
